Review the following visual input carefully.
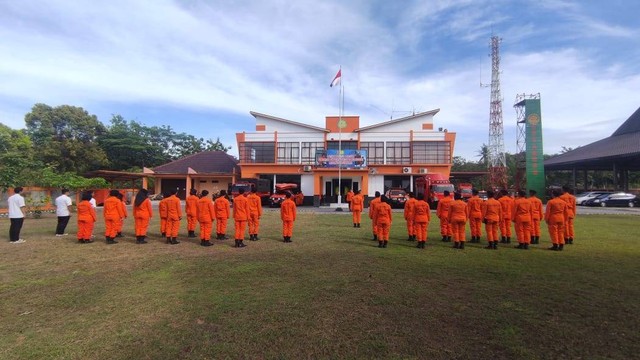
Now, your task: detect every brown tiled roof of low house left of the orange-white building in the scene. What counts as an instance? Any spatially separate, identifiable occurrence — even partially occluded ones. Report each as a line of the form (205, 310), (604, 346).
(153, 151), (239, 175)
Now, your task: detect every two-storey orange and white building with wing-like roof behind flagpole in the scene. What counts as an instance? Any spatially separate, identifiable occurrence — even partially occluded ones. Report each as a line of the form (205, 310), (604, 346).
(236, 109), (455, 206)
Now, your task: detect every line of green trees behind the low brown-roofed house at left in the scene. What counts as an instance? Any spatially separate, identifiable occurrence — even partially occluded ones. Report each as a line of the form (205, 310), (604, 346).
(0, 104), (231, 189)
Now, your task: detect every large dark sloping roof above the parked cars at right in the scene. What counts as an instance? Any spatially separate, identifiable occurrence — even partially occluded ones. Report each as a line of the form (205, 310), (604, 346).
(544, 108), (640, 170)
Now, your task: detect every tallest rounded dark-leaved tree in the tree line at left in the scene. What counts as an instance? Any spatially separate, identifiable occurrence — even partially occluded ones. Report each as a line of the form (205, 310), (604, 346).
(25, 104), (108, 174)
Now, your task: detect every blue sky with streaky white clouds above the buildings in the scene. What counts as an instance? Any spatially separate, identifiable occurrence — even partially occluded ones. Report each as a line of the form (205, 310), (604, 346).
(0, 0), (640, 161)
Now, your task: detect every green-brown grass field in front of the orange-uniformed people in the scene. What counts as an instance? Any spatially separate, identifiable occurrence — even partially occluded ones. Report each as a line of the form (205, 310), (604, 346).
(0, 212), (640, 359)
